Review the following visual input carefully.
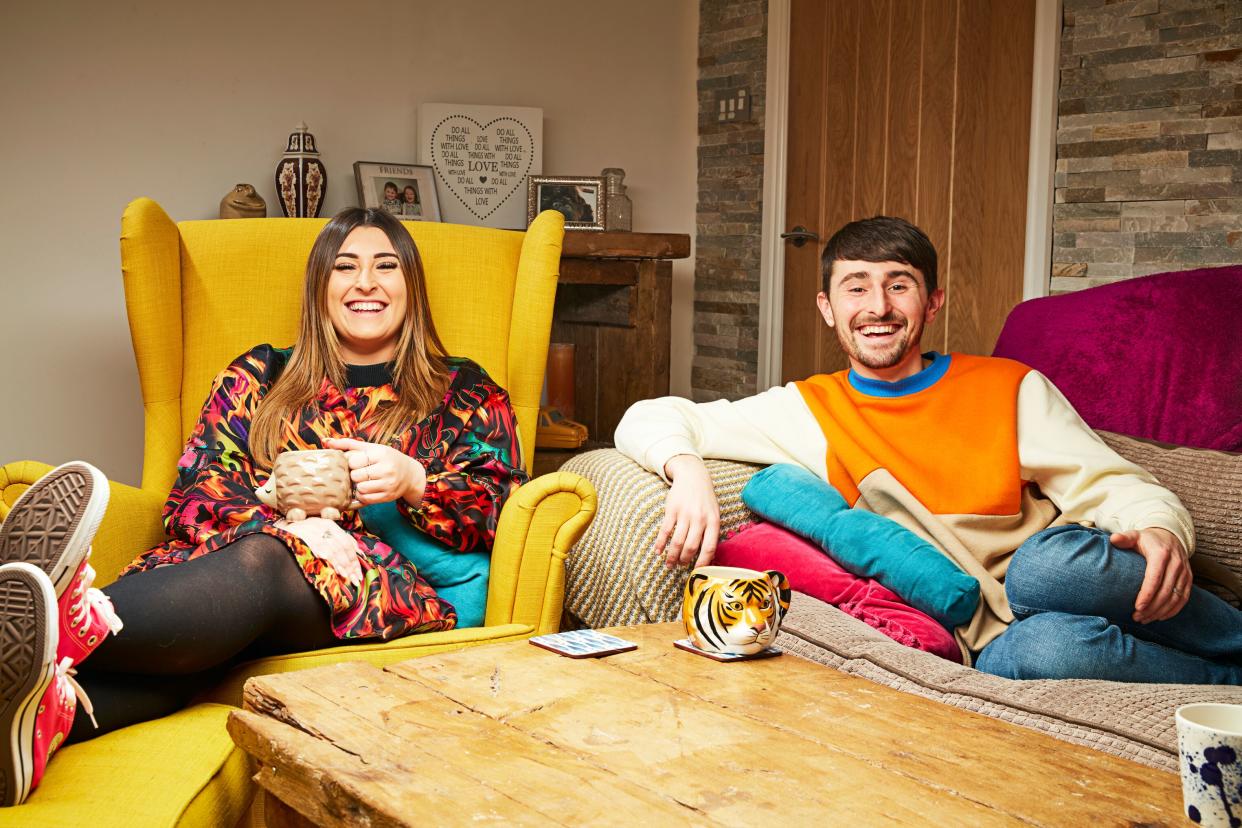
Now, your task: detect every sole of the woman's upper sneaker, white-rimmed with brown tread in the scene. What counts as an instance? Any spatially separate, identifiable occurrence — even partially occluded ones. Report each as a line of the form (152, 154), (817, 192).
(0, 461), (108, 598)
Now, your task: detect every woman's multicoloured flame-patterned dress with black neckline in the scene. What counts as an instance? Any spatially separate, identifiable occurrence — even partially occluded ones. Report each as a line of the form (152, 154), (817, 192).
(124, 345), (527, 639)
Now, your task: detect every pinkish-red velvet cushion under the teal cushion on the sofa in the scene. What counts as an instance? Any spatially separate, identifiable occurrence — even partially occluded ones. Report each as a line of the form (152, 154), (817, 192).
(713, 523), (961, 664)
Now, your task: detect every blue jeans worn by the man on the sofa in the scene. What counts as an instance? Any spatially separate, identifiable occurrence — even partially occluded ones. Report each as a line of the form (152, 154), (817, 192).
(975, 526), (1242, 684)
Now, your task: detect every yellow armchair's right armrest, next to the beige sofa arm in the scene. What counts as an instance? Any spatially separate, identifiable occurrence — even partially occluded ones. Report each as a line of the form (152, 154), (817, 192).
(484, 472), (595, 634)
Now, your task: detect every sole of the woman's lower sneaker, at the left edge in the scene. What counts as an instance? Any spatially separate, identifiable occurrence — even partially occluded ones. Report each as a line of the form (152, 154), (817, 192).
(0, 562), (58, 806)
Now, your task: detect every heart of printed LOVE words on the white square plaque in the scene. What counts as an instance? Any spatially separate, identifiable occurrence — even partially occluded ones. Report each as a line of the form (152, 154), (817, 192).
(428, 114), (534, 221)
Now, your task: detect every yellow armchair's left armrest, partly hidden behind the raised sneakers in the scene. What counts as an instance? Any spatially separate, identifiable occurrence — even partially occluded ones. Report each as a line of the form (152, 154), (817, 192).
(0, 461), (165, 586)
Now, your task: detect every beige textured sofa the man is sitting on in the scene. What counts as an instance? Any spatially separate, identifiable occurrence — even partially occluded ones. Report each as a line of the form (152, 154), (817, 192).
(564, 432), (1242, 772)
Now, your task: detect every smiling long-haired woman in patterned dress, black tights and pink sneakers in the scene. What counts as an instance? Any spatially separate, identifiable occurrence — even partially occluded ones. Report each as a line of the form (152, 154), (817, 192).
(0, 209), (525, 804)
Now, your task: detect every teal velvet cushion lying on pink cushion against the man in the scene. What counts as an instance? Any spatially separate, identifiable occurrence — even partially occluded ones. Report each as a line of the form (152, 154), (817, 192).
(741, 464), (979, 629)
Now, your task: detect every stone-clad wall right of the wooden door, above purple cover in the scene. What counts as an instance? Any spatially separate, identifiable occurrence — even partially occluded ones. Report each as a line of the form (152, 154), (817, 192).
(1052, 0), (1242, 293)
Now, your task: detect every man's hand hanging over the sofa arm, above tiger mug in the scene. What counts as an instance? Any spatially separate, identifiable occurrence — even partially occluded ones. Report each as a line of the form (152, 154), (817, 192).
(655, 454), (720, 569)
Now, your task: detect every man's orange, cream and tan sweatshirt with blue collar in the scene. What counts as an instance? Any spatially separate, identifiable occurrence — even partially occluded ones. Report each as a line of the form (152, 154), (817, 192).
(616, 351), (1195, 652)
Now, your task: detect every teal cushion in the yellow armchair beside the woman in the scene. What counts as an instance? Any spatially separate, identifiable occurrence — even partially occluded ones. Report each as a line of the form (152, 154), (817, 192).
(360, 503), (492, 629)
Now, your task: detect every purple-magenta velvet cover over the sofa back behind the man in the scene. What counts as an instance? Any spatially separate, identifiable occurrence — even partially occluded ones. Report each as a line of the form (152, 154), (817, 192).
(992, 267), (1242, 452)
